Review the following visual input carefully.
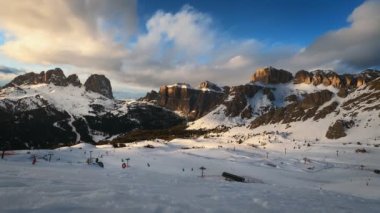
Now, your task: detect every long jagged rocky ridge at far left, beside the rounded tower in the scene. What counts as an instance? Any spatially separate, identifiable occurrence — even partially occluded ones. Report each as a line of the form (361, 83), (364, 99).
(4, 68), (81, 88)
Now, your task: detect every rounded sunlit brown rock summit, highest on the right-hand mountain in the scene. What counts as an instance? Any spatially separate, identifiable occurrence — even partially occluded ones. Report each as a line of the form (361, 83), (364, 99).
(251, 67), (293, 84)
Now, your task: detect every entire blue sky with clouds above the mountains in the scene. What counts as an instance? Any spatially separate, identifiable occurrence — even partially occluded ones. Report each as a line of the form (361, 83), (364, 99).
(0, 0), (380, 97)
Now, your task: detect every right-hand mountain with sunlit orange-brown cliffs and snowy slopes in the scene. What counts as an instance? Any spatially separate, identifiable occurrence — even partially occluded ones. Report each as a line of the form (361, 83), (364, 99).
(140, 67), (380, 140)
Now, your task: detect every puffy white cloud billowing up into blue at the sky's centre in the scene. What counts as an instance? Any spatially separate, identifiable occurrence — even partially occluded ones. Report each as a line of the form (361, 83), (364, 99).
(115, 6), (299, 88)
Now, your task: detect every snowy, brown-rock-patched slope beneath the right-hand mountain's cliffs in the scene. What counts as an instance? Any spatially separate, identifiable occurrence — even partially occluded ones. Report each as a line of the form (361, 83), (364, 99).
(188, 79), (380, 141)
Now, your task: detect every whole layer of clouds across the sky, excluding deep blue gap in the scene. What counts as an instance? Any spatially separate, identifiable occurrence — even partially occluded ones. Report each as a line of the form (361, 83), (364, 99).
(0, 0), (380, 94)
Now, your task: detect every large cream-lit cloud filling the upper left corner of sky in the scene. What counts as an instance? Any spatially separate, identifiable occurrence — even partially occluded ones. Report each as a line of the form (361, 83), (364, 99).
(0, 0), (137, 70)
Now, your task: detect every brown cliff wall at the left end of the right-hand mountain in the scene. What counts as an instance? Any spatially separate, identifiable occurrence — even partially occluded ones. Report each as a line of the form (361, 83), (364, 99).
(158, 84), (224, 120)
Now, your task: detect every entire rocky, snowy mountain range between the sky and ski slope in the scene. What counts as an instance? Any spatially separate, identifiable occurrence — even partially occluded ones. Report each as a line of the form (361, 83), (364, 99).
(0, 67), (380, 149)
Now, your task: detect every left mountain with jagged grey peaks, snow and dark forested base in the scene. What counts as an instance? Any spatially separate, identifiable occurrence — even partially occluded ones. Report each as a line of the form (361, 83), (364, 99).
(0, 69), (182, 149)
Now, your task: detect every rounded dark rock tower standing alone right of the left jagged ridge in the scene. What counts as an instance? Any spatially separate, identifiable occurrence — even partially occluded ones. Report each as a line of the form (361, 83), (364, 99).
(84, 74), (113, 99)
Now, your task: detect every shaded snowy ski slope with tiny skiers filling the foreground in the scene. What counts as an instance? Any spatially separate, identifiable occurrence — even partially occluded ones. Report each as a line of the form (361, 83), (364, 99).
(0, 138), (380, 212)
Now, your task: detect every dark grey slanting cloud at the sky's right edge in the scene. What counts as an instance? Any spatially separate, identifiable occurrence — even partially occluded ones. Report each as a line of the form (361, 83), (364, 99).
(291, 0), (380, 72)
